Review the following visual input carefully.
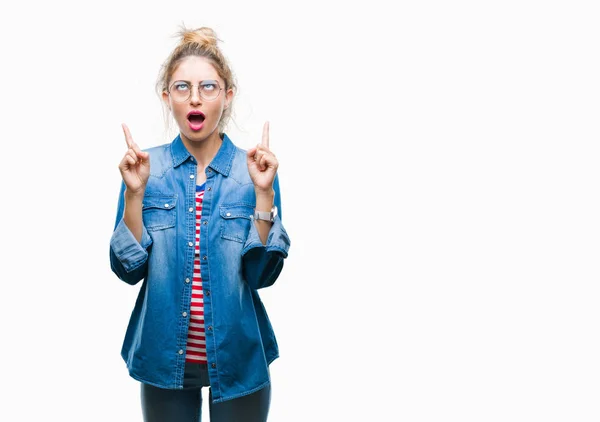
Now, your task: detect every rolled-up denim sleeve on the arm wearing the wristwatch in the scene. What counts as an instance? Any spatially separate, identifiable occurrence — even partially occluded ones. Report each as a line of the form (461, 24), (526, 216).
(242, 175), (290, 289)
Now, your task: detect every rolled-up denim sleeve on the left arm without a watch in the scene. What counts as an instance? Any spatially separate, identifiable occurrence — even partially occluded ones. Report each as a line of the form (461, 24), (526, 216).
(110, 182), (152, 285)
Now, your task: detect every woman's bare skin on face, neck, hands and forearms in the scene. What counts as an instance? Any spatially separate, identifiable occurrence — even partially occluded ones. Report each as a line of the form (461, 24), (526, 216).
(119, 56), (279, 244)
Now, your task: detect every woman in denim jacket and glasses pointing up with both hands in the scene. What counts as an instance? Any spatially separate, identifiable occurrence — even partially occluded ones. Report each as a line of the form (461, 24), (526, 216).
(110, 28), (290, 422)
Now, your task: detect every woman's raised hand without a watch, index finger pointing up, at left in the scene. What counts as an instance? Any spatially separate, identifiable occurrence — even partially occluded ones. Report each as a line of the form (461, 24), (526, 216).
(119, 123), (150, 195)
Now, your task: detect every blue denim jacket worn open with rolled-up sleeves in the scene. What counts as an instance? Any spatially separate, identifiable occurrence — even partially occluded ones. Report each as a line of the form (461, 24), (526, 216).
(110, 134), (290, 403)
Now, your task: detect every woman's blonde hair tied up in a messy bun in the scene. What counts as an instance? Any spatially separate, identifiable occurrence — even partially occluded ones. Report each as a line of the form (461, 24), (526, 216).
(156, 26), (237, 133)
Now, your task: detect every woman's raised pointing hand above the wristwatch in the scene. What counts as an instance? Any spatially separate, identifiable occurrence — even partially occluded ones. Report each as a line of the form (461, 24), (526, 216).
(246, 122), (279, 192)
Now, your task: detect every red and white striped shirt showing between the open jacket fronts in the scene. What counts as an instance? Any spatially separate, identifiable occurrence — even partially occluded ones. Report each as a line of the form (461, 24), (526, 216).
(185, 183), (206, 363)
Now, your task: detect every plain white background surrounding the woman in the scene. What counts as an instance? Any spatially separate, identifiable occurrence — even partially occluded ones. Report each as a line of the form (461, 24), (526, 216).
(0, 0), (600, 422)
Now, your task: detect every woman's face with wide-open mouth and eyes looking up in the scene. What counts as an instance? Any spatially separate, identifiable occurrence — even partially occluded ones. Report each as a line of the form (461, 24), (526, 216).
(163, 56), (233, 143)
